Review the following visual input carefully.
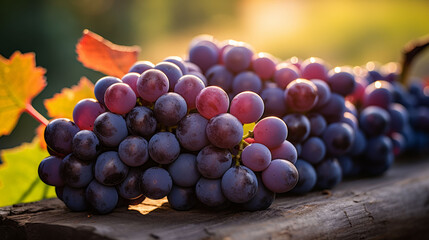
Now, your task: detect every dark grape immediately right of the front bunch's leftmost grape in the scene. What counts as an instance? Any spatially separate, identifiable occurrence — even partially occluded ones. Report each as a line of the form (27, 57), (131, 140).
(60, 154), (94, 188)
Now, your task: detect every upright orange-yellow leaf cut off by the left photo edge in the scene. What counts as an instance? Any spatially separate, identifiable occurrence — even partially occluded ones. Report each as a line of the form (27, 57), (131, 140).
(0, 51), (46, 136)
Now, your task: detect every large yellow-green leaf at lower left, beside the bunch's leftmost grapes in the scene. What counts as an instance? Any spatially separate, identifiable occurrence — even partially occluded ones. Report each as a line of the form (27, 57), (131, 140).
(0, 137), (56, 207)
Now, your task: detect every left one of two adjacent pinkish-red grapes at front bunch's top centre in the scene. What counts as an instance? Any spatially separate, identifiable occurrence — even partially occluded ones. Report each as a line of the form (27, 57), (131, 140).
(195, 86), (229, 119)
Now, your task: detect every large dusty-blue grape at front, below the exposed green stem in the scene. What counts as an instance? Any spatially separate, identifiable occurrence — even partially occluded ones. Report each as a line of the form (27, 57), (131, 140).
(221, 166), (258, 203)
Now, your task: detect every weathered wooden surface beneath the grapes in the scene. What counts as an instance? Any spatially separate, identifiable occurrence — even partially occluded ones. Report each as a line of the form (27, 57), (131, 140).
(0, 159), (429, 240)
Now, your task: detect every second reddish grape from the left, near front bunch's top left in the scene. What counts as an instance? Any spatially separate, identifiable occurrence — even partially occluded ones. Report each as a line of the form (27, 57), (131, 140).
(104, 83), (137, 114)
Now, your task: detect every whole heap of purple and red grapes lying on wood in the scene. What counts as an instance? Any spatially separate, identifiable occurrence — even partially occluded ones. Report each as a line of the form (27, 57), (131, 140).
(39, 35), (429, 214)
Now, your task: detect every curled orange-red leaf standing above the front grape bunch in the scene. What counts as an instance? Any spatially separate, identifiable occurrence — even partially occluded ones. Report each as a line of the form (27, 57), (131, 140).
(76, 29), (140, 78)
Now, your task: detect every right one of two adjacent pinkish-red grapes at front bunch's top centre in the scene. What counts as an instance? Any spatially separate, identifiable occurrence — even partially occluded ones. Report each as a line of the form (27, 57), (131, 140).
(229, 91), (264, 124)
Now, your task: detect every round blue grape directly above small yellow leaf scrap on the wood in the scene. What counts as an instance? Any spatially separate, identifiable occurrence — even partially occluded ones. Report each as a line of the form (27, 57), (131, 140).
(141, 167), (173, 199)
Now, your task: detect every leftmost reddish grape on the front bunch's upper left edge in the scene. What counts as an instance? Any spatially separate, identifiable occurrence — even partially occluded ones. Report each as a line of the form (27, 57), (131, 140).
(73, 98), (106, 131)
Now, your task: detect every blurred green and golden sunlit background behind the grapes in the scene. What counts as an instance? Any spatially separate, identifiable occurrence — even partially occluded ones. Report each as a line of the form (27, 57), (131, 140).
(0, 0), (429, 149)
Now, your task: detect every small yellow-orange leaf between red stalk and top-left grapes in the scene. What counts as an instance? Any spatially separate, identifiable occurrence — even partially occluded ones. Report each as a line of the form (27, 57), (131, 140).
(43, 77), (95, 119)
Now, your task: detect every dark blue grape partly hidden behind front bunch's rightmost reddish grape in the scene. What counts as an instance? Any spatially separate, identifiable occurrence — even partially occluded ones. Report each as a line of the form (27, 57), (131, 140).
(290, 159), (317, 194)
